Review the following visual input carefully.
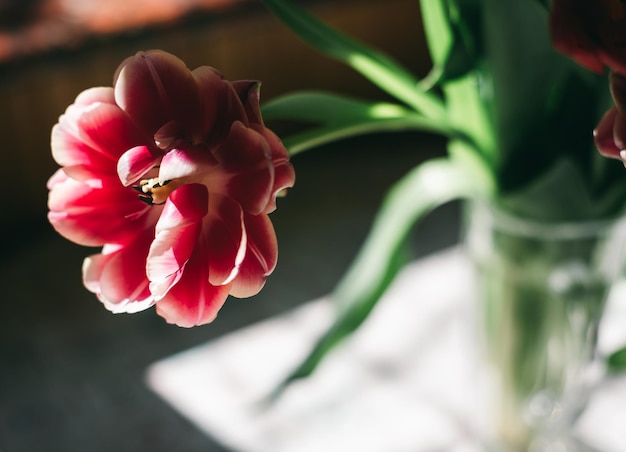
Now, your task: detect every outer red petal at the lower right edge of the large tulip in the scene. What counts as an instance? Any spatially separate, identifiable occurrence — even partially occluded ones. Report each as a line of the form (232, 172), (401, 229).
(230, 214), (278, 298)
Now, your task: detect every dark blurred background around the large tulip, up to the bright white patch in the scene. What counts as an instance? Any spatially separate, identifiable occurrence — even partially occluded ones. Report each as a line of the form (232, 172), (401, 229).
(0, 0), (459, 452)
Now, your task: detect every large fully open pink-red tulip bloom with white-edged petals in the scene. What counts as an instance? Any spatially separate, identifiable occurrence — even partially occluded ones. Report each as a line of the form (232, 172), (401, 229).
(48, 50), (295, 327)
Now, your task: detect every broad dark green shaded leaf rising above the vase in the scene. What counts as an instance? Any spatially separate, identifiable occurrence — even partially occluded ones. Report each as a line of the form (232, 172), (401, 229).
(484, 0), (606, 183)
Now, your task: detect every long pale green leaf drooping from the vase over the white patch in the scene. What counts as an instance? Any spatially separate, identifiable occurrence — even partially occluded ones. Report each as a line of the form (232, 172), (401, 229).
(274, 158), (491, 396)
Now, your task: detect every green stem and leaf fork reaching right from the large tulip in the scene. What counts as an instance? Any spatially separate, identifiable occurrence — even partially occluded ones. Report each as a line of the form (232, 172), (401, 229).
(263, 91), (463, 155)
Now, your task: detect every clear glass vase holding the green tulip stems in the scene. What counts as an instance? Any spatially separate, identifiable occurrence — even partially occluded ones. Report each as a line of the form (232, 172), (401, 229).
(465, 203), (626, 452)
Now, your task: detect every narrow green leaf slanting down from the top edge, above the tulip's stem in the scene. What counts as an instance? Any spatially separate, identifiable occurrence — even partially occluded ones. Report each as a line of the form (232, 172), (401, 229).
(263, 0), (445, 120)
